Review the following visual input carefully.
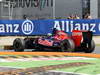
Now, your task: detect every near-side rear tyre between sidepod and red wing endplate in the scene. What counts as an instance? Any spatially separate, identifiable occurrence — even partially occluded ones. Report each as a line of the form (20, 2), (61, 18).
(61, 39), (75, 52)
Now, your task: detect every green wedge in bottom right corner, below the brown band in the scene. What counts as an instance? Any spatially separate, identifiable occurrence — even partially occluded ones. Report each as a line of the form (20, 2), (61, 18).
(56, 59), (100, 75)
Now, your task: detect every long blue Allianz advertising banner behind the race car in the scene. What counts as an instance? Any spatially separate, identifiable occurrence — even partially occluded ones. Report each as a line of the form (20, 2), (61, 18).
(0, 19), (100, 36)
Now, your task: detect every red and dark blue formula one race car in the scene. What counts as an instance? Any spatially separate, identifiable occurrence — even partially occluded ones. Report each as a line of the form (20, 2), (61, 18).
(13, 29), (95, 53)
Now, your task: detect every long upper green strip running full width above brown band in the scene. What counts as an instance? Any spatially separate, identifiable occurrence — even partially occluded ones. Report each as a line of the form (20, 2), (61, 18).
(0, 59), (100, 68)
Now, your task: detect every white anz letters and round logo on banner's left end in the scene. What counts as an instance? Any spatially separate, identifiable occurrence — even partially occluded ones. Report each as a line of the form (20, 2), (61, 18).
(0, 20), (34, 35)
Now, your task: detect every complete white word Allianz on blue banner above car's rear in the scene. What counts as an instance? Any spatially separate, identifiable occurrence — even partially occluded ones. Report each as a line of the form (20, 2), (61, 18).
(53, 20), (97, 32)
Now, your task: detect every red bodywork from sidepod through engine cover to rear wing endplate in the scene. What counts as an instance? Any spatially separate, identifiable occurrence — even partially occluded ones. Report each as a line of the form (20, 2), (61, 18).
(38, 30), (82, 47)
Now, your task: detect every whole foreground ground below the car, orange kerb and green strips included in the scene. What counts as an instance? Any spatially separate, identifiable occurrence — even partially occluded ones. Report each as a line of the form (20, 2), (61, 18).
(0, 46), (100, 75)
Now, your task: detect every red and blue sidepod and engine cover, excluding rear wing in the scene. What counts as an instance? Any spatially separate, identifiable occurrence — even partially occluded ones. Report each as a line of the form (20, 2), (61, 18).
(38, 31), (69, 46)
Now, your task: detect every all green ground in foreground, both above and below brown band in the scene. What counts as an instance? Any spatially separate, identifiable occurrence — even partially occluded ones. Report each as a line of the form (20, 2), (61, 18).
(0, 55), (100, 75)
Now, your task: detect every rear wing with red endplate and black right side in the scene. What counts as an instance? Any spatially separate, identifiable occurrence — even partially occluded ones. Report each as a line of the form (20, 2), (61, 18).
(72, 30), (93, 46)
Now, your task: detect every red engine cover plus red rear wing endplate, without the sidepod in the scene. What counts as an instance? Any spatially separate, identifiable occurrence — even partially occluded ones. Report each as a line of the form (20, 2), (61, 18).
(54, 30), (83, 47)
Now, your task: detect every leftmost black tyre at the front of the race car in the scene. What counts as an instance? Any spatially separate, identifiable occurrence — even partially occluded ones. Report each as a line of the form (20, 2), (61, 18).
(13, 38), (25, 52)
